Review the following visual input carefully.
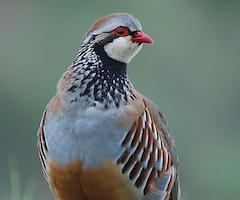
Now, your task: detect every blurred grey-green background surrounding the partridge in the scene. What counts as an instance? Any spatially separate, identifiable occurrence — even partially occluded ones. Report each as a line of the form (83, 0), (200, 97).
(0, 0), (240, 200)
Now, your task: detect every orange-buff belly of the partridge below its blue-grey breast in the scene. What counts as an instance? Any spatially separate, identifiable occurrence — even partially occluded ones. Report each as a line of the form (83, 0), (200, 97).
(48, 160), (141, 200)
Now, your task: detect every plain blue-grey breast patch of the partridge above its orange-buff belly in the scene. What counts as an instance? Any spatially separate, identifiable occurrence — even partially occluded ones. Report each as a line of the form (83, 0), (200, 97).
(44, 103), (133, 168)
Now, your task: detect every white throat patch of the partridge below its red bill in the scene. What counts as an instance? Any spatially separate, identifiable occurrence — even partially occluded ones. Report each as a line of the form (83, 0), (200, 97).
(104, 36), (142, 63)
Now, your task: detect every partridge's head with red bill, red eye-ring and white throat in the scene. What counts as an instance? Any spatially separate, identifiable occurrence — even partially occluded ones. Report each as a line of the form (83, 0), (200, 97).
(83, 13), (153, 64)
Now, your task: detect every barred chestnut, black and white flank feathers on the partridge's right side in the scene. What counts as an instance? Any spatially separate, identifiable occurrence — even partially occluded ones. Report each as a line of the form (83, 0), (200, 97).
(117, 104), (176, 200)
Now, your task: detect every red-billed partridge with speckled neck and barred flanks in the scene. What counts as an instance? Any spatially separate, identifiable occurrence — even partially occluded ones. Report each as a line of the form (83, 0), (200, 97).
(38, 13), (180, 200)
